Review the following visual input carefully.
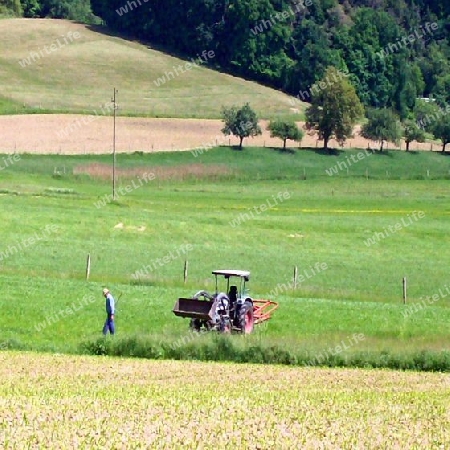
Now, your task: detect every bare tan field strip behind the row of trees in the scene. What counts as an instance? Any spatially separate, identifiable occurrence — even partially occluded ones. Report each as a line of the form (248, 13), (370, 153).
(0, 114), (438, 154)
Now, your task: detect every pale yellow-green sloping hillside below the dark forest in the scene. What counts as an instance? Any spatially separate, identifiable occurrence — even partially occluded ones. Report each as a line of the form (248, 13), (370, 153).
(0, 19), (301, 118)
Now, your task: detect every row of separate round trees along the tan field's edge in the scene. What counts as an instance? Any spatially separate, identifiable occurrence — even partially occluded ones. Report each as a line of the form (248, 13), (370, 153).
(222, 66), (450, 151)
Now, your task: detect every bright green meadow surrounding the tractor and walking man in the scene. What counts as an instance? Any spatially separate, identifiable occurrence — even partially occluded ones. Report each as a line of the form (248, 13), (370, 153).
(0, 147), (450, 368)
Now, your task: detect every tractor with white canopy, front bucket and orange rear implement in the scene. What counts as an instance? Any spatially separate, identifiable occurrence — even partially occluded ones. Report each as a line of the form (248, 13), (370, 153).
(173, 270), (278, 334)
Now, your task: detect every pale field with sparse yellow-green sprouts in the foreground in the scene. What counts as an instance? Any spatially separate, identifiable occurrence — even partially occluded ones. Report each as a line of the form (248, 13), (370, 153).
(0, 352), (450, 450)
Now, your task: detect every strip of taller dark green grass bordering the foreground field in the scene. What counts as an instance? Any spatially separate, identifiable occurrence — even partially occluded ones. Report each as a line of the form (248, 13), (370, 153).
(80, 333), (450, 372)
